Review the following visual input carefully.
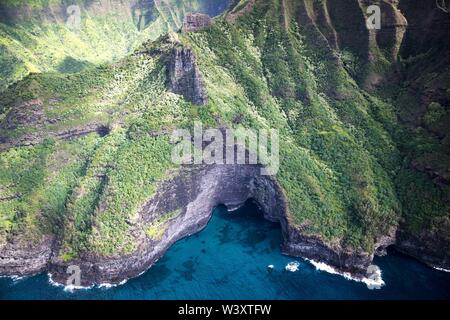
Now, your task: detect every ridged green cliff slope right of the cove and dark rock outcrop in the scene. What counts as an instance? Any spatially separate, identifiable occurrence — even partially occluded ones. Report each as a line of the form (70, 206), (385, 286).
(183, 1), (401, 250)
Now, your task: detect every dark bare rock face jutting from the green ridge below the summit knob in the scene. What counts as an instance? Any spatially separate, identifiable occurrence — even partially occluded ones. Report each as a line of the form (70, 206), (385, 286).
(169, 47), (208, 106)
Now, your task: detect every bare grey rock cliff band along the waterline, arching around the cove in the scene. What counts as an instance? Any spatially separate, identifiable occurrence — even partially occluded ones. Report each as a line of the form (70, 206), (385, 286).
(0, 165), (449, 287)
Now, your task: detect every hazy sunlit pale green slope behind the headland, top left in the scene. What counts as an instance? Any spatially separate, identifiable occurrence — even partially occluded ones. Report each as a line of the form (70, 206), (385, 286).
(0, 0), (230, 90)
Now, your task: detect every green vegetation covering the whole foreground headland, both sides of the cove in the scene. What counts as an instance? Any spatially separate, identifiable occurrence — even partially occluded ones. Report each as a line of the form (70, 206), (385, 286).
(0, 1), (448, 260)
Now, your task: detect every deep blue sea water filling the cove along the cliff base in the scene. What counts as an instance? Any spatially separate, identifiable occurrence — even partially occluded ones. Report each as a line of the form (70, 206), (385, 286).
(0, 205), (450, 299)
